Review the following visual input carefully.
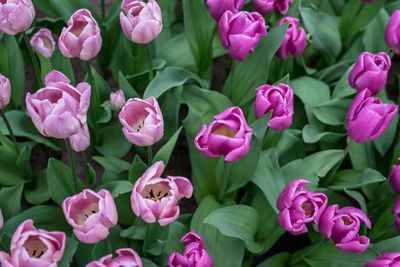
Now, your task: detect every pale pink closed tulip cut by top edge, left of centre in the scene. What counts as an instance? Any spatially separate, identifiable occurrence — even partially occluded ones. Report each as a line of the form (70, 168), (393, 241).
(119, 0), (162, 44)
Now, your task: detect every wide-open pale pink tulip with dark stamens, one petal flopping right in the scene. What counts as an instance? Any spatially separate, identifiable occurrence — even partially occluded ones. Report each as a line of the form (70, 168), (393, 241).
(131, 161), (193, 226)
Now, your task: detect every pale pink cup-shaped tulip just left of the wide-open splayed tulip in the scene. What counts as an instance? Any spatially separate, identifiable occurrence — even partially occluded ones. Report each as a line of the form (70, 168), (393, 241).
(62, 189), (118, 244)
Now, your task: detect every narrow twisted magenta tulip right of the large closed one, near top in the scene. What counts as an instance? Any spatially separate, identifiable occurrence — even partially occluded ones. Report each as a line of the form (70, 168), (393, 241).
(276, 17), (307, 59)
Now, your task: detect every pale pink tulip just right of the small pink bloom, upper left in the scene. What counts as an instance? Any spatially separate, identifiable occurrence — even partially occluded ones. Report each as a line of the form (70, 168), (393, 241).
(58, 9), (102, 61)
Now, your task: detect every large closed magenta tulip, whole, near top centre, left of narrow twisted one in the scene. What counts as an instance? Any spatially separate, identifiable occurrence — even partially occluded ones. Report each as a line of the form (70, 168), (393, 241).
(219, 10), (268, 61)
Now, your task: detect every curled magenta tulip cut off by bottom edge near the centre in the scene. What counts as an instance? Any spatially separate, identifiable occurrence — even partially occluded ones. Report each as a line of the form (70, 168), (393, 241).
(168, 232), (214, 267)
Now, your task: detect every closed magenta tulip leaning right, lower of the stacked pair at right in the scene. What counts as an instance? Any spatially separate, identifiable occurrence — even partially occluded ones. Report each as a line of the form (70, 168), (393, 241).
(346, 89), (398, 144)
